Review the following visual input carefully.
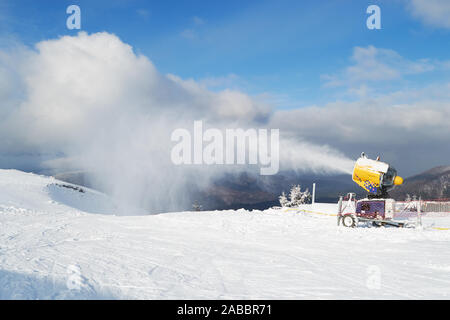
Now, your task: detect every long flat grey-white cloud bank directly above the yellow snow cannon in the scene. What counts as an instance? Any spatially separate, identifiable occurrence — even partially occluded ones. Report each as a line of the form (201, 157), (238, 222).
(270, 83), (450, 175)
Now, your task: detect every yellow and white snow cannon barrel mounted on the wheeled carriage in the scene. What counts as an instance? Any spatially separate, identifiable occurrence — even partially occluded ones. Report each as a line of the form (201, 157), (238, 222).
(352, 152), (403, 198)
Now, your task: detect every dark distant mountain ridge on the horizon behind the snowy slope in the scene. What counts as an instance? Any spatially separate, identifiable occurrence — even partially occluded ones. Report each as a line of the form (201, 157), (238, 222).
(55, 166), (450, 210)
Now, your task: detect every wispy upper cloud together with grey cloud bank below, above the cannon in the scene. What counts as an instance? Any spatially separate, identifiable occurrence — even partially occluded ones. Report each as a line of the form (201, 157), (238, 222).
(312, 46), (450, 174)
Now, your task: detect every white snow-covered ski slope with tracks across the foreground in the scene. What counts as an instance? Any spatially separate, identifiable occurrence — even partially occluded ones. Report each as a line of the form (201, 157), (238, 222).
(0, 170), (450, 299)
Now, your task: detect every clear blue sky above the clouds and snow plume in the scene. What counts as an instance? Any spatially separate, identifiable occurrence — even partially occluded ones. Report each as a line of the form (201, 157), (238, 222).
(0, 0), (450, 109)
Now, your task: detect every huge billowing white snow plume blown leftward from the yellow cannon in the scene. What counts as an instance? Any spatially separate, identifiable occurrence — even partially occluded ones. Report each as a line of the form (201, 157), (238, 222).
(0, 32), (356, 214)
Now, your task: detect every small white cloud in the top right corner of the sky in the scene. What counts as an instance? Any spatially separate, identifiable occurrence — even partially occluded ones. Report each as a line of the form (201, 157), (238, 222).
(407, 0), (450, 29)
